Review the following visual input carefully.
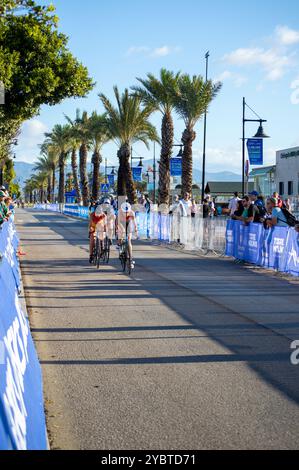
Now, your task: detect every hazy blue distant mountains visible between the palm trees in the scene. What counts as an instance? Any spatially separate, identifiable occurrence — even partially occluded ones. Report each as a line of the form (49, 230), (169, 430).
(15, 160), (241, 186)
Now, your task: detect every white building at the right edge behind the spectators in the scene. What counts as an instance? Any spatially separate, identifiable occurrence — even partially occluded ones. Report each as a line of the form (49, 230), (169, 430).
(275, 147), (299, 199)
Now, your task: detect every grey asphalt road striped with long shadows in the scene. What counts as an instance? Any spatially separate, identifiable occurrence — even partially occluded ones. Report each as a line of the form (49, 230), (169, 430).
(17, 210), (299, 450)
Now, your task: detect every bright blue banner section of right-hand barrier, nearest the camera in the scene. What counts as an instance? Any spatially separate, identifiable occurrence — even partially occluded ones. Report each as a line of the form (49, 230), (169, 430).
(225, 220), (299, 276)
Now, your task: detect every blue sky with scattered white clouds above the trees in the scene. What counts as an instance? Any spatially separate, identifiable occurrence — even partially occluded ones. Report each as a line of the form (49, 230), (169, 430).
(17, 0), (299, 172)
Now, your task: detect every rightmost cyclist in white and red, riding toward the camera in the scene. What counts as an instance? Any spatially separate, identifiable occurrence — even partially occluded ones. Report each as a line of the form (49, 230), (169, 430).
(116, 202), (138, 269)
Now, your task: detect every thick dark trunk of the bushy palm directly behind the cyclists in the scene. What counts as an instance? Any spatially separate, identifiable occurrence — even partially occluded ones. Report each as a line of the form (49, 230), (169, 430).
(117, 144), (137, 204)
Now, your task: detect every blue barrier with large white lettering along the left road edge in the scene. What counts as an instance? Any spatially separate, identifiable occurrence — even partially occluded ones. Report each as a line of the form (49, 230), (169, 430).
(0, 220), (47, 450)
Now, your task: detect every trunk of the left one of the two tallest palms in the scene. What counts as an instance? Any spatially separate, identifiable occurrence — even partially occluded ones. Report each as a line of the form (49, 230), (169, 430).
(159, 113), (174, 205)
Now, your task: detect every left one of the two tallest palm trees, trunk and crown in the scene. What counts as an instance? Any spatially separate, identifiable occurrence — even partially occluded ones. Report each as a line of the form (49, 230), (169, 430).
(132, 69), (180, 204)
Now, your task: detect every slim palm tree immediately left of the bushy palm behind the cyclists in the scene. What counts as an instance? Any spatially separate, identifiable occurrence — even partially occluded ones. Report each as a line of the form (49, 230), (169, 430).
(88, 112), (111, 200)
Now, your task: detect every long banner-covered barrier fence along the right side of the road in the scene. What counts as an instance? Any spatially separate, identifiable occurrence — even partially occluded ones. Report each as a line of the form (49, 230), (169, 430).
(32, 204), (299, 276)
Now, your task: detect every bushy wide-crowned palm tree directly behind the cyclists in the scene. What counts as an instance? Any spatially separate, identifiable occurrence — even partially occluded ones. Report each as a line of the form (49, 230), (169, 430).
(99, 86), (159, 203)
